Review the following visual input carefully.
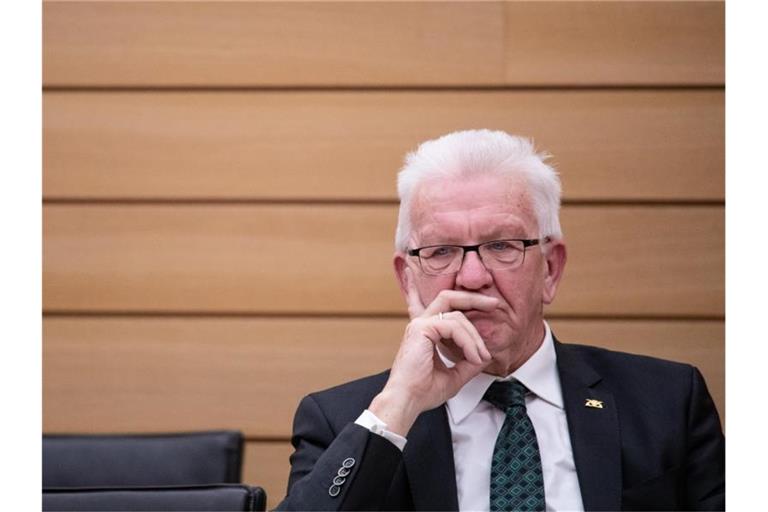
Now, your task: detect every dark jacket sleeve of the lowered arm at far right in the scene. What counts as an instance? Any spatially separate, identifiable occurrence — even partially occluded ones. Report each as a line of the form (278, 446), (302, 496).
(685, 368), (725, 510)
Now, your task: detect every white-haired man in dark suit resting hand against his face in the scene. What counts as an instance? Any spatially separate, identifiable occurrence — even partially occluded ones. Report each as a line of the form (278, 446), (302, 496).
(278, 130), (725, 510)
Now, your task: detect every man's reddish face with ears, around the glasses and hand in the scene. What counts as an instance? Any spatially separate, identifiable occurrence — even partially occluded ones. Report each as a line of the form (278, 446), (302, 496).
(395, 176), (565, 370)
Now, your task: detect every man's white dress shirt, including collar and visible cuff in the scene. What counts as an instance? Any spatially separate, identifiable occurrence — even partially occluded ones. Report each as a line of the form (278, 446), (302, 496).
(356, 322), (584, 511)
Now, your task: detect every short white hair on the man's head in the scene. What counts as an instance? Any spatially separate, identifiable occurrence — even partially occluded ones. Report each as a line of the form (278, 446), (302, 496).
(395, 130), (562, 252)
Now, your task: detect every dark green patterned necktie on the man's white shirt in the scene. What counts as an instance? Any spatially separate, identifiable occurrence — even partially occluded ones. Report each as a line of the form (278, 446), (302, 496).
(483, 381), (544, 512)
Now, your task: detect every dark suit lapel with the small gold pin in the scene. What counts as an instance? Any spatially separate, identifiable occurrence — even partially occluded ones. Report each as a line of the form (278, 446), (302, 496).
(555, 340), (621, 510)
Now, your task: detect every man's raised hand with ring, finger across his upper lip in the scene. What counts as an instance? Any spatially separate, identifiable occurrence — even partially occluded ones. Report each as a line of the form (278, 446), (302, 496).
(369, 269), (498, 436)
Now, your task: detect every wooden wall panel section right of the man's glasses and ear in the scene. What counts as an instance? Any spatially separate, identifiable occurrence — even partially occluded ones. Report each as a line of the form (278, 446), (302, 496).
(550, 206), (725, 317)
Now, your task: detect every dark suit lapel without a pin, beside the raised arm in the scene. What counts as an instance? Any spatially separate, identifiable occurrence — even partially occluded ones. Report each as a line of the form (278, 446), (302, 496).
(403, 405), (459, 510)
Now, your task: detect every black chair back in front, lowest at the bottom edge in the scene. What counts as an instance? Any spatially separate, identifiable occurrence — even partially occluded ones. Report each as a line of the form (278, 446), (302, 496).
(43, 485), (267, 512)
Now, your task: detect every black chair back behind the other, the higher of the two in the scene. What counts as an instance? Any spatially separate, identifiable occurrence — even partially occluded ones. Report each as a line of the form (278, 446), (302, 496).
(43, 431), (243, 488)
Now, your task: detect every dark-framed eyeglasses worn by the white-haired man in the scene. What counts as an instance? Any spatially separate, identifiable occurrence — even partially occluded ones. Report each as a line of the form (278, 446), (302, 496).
(408, 237), (550, 276)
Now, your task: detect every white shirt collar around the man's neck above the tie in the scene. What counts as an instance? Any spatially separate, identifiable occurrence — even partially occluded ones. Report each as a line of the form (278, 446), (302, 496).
(438, 322), (563, 423)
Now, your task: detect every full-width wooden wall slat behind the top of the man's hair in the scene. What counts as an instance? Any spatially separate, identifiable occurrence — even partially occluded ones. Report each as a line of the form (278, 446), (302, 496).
(43, 90), (725, 201)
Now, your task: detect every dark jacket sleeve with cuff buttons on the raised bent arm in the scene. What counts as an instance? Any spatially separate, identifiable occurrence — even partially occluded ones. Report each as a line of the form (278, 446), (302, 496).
(276, 395), (402, 510)
